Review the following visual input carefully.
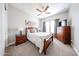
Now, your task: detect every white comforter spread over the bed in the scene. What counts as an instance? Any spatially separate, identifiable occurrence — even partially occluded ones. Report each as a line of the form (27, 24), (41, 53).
(27, 32), (52, 53)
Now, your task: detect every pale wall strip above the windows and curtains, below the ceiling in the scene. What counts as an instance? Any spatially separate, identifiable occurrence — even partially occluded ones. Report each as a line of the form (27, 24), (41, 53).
(40, 11), (68, 30)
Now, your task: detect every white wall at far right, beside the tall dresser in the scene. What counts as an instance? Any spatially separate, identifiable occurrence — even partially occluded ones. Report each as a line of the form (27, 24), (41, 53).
(69, 4), (79, 54)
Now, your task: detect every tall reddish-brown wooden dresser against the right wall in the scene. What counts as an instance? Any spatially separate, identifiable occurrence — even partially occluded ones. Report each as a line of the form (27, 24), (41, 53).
(57, 26), (71, 44)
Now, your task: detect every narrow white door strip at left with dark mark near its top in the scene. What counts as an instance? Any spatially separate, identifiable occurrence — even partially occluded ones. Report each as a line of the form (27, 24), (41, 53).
(3, 4), (8, 47)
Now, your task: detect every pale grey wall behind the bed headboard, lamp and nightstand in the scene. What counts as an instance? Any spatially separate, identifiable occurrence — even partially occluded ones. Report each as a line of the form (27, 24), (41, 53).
(8, 4), (39, 45)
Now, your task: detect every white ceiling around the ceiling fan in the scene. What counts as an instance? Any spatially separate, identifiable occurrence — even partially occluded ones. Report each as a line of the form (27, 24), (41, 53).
(11, 3), (70, 18)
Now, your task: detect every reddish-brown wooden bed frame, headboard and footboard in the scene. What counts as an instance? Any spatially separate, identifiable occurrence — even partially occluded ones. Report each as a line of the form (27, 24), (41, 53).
(26, 27), (53, 55)
